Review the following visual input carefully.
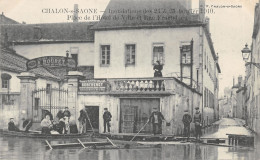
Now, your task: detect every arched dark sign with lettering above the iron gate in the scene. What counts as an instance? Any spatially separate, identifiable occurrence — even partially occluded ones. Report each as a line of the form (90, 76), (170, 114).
(26, 56), (76, 70)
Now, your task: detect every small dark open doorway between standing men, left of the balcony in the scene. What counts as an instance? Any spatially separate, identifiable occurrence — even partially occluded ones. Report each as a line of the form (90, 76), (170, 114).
(85, 106), (99, 132)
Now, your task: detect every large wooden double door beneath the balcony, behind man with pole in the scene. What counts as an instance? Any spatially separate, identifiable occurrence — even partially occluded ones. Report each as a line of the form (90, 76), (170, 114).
(119, 98), (160, 133)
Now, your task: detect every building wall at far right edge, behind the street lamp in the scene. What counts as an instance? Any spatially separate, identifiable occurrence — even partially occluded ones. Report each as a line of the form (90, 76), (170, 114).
(245, 0), (260, 133)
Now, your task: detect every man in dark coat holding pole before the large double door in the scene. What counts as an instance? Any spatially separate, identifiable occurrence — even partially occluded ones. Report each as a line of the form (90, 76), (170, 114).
(148, 108), (165, 135)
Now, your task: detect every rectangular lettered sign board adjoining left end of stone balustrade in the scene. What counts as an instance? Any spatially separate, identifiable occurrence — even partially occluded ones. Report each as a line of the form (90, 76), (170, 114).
(79, 79), (107, 92)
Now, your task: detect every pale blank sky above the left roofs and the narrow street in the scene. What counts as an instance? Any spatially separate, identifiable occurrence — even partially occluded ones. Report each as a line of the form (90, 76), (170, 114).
(0, 0), (259, 95)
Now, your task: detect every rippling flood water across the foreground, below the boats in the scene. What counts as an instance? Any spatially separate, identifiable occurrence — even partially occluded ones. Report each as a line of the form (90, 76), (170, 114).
(0, 137), (260, 160)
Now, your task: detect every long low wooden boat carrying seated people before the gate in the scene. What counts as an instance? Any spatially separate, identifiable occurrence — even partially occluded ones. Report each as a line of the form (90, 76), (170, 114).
(0, 130), (90, 139)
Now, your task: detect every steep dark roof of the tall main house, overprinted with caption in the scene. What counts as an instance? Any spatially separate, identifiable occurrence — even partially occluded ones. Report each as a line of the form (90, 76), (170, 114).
(93, 0), (202, 30)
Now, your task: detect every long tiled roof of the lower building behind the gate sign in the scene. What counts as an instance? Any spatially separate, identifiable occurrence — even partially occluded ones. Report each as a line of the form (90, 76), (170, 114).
(1, 22), (96, 44)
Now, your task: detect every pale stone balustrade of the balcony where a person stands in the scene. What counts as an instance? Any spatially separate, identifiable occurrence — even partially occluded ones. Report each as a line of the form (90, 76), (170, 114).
(109, 78), (169, 92)
